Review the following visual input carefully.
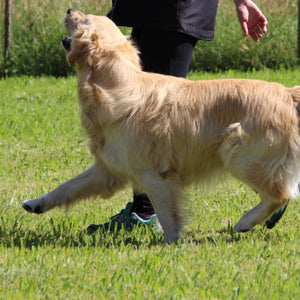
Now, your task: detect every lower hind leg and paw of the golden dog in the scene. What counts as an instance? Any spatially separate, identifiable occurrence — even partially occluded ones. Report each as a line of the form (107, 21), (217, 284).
(233, 195), (288, 232)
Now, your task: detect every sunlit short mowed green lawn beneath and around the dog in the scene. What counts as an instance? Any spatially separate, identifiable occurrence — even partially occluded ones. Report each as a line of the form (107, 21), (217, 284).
(0, 70), (300, 299)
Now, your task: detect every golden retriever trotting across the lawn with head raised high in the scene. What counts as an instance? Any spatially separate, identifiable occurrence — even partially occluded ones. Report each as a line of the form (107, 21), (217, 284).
(23, 9), (300, 243)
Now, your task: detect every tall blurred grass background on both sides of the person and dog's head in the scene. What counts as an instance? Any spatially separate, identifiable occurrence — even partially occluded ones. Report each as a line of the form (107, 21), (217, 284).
(0, 0), (299, 77)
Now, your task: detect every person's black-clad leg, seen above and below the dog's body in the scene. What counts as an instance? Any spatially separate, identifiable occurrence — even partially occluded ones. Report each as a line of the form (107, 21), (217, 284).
(131, 28), (197, 217)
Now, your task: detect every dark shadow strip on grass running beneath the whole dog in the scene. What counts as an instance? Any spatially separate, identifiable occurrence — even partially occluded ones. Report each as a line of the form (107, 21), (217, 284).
(0, 220), (267, 249)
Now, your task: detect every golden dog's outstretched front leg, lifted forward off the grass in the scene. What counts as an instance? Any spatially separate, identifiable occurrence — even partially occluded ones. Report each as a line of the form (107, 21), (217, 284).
(22, 163), (123, 214)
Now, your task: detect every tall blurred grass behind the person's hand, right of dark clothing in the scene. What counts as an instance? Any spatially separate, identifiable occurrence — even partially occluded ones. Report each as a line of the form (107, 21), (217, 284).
(191, 0), (299, 71)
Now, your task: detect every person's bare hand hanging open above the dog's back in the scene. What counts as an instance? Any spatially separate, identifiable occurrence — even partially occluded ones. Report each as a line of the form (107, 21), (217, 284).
(234, 0), (268, 42)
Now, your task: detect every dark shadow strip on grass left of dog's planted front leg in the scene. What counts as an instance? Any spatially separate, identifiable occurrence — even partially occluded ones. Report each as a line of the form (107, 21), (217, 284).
(0, 220), (164, 249)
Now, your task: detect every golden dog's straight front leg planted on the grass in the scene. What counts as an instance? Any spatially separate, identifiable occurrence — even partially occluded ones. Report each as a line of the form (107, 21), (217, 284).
(140, 172), (188, 244)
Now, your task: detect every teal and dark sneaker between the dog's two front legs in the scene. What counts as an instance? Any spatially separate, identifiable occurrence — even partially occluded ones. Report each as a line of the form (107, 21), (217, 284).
(87, 202), (158, 234)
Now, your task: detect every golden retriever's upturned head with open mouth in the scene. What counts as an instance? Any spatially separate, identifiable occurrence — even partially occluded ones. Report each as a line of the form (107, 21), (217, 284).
(62, 9), (127, 65)
